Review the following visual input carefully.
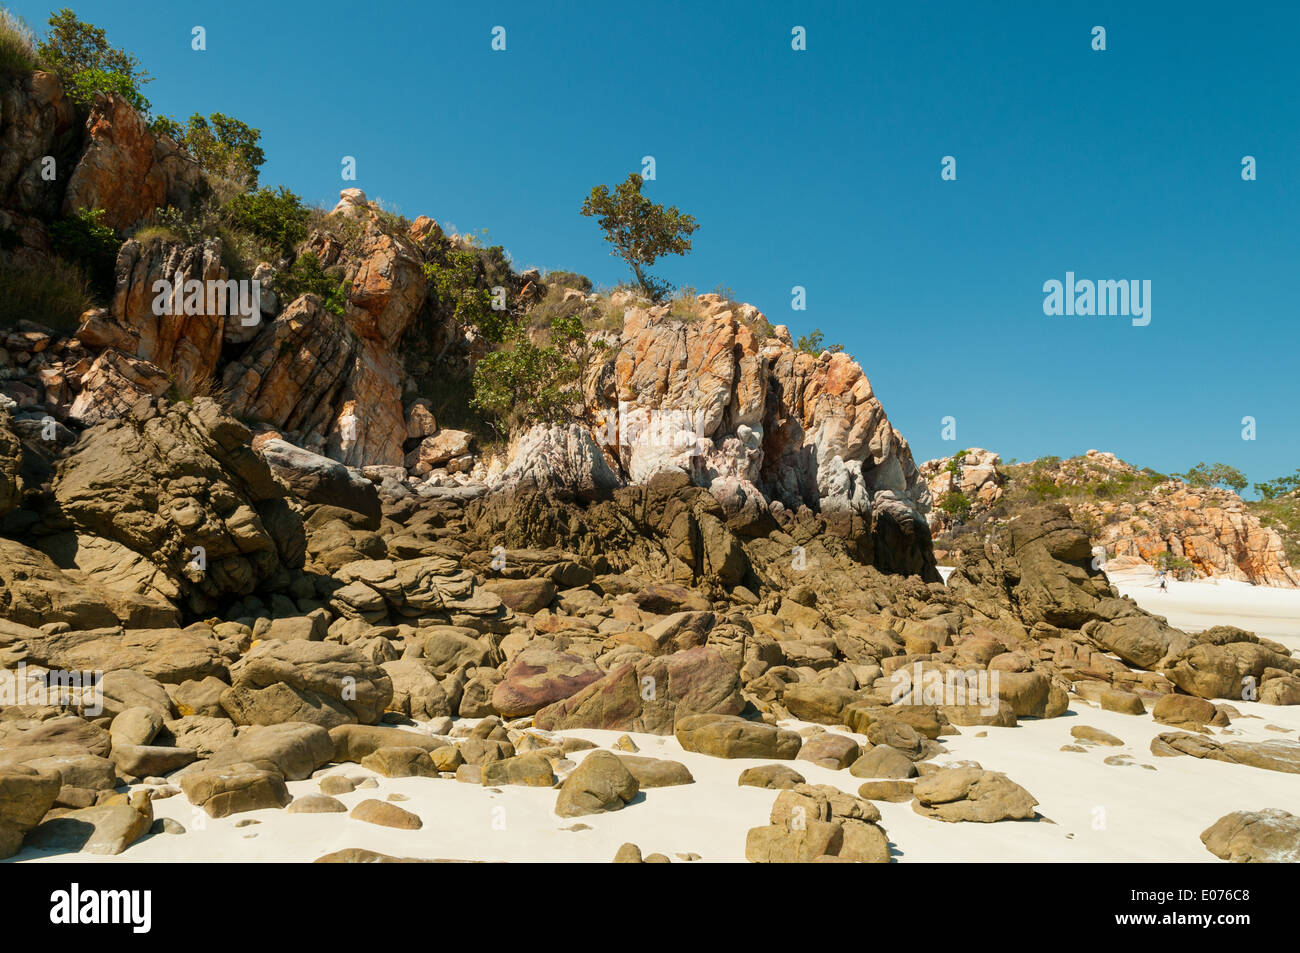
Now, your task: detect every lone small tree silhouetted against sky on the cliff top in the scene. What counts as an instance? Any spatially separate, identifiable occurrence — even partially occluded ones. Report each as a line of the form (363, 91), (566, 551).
(582, 172), (699, 300)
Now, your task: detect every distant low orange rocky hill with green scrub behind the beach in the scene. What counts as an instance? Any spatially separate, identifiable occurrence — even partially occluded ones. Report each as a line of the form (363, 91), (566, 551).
(920, 447), (1300, 588)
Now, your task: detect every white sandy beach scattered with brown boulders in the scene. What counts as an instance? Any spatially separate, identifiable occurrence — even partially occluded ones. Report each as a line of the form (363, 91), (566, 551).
(14, 564), (1300, 862)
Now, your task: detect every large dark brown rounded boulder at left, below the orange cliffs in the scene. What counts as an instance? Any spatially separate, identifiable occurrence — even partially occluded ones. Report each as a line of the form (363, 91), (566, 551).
(47, 399), (306, 612)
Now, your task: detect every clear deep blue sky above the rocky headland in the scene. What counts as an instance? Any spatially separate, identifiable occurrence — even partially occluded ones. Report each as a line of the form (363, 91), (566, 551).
(10, 0), (1300, 491)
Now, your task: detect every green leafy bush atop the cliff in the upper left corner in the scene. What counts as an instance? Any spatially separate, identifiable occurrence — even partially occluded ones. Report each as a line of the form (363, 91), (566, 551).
(36, 7), (152, 113)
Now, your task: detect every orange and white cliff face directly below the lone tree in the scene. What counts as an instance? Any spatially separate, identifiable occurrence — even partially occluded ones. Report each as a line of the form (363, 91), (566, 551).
(494, 295), (937, 579)
